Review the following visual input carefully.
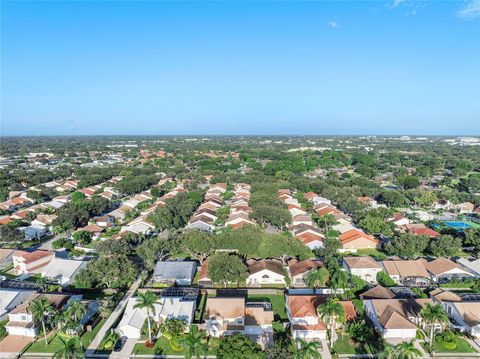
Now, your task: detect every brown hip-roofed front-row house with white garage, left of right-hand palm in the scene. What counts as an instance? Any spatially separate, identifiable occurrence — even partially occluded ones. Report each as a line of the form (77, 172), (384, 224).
(363, 299), (433, 342)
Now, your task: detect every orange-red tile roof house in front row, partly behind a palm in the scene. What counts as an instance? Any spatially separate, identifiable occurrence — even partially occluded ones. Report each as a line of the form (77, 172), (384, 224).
(286, 295), (356, 341)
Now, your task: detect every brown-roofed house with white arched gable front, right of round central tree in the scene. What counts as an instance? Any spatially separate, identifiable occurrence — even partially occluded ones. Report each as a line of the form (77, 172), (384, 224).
(247, 259), (286, 286)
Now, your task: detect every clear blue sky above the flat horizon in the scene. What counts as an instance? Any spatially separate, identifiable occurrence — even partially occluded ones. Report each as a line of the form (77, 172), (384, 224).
(1, 0), (480, 135)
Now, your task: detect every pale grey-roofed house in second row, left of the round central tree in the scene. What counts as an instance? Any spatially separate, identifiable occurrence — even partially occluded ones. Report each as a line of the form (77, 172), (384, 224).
(153, 261), (197, 286)
